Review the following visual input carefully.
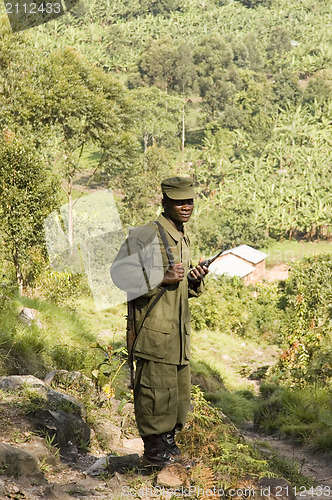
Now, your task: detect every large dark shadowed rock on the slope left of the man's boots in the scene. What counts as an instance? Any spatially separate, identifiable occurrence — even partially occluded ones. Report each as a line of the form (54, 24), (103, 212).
(31, 408), (90, 459)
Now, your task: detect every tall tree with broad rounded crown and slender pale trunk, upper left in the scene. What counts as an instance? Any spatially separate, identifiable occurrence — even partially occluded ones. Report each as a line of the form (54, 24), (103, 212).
(11, 48), (135, 250)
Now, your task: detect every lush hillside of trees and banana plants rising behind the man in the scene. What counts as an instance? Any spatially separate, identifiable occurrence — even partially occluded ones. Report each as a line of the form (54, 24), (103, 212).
(1, 0), (332, 250)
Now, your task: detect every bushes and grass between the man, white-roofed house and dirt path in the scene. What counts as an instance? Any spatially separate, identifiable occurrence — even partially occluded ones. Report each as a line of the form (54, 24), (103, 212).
(189, 253), (332, 451)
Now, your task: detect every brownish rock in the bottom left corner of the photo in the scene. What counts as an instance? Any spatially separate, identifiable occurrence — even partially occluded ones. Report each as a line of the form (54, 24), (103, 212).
(0, 443), (44, 481)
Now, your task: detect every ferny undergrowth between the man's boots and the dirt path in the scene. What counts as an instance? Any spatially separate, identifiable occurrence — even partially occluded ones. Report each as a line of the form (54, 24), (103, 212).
(178, 387), (310, 488)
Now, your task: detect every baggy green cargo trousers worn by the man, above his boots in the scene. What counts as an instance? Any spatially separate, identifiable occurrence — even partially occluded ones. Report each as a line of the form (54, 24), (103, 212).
(134, 358), (191, 437)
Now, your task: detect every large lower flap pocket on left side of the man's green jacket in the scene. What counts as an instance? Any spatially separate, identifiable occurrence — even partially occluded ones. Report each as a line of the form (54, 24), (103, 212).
(135, 316), (173, 359)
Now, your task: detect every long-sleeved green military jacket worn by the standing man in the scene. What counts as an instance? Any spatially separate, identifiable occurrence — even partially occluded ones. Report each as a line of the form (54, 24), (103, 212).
(111, 215), (204, 365)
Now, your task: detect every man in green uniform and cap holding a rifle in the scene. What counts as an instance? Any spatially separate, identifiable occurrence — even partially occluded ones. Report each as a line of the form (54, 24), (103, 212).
(111, 177), (208, 466)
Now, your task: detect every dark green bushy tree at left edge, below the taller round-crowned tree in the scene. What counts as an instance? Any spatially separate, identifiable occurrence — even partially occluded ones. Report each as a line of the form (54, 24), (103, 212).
(0, 137), (59, 292)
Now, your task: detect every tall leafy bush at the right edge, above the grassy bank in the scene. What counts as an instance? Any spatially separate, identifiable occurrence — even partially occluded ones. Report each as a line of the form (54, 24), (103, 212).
(273, 253), (332, 384)
